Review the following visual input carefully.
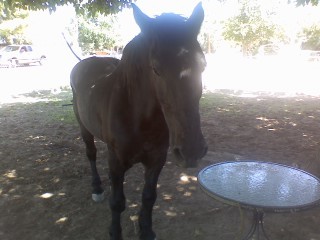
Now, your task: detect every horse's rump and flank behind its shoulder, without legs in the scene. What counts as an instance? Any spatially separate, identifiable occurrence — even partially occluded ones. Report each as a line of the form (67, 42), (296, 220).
(70, 57), (120, 140)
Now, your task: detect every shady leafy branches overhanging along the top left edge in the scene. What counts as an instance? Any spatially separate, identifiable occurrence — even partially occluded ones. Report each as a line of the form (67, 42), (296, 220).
(3, 0), (132, 15)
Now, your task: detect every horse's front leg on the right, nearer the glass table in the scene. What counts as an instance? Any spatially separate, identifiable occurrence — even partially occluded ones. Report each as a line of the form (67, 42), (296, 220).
(139, 153), (166, 240)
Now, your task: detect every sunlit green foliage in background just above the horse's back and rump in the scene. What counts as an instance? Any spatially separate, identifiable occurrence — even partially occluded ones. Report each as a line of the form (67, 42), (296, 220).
(78, 14), (116, 53)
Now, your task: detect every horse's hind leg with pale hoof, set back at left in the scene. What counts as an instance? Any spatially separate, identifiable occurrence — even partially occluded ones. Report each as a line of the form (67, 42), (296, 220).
(80, 124), (104, 202)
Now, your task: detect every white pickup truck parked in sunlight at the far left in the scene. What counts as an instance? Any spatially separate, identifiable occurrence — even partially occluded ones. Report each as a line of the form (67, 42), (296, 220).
(0, 45), (46, 67)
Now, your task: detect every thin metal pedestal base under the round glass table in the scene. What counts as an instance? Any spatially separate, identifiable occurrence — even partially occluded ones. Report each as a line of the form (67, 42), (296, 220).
(242, 210), (270, 240)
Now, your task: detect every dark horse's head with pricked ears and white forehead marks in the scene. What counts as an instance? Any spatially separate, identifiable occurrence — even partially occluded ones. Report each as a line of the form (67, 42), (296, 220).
(133, 3), (207, 167)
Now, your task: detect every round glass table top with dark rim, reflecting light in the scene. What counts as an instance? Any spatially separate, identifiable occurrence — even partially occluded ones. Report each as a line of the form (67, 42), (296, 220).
(198, 161), (320, 212)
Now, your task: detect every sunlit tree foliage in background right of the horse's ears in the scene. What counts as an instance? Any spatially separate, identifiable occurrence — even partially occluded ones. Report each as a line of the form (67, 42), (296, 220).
(222, 0), (279, 55)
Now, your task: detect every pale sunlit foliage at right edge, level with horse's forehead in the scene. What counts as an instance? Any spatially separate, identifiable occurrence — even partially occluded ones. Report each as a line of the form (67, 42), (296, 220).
(299, 24), (320, 51)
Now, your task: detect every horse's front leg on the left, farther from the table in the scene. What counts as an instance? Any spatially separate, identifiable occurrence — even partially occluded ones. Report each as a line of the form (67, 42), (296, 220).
(108, 150), (126, 240)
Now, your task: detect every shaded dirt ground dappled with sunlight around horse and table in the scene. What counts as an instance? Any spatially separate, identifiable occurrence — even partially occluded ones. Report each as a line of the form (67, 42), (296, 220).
(0, 89), (320, 240)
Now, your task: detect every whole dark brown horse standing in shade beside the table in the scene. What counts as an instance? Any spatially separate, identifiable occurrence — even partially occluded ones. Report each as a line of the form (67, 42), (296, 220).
(71, 4), (207, 240)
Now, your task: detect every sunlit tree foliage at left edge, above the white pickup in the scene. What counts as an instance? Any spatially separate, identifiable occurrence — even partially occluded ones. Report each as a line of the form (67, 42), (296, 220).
(0, 2), (28, 44)
